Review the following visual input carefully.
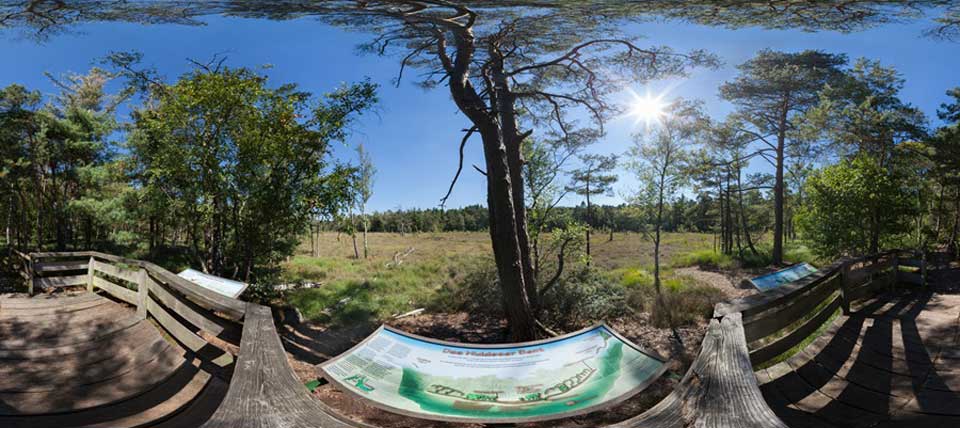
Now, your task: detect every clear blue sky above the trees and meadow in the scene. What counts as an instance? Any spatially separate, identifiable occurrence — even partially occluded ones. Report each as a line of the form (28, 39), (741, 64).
(0, 13), (960, 210)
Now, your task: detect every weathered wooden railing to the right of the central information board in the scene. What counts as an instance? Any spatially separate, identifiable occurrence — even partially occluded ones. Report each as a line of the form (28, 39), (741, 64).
(611, 250), (926, 428)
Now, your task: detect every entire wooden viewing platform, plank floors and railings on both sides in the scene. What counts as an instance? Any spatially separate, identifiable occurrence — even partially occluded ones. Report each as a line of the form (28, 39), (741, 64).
(0, 250), (960, 428)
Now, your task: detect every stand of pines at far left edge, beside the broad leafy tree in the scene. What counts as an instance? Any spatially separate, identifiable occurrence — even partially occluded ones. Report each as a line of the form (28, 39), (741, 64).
(0, 69), (123, 249)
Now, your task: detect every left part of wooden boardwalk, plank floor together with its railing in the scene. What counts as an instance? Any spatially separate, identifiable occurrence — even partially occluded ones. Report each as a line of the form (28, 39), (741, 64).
(0, 251), (366, 428)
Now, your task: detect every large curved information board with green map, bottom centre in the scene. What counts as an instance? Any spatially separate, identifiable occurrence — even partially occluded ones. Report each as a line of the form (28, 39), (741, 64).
(321, 325), (666, 422)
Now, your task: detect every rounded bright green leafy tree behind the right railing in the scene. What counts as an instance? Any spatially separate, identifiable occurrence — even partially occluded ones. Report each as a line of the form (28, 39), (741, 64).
(797, 154), (915, 258)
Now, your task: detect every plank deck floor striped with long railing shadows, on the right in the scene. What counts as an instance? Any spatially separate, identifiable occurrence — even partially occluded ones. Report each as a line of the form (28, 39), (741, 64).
(756, 271), (960, 428)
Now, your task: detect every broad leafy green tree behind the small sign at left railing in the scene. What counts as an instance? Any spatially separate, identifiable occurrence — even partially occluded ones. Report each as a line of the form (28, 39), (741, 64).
(130, 62), (376, 280)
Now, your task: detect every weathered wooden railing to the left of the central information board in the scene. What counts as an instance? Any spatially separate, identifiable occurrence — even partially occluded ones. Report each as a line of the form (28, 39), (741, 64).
(15, 251), (366, 428)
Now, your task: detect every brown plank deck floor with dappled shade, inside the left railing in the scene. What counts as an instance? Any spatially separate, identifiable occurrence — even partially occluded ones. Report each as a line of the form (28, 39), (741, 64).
(0, 293), (227, 428)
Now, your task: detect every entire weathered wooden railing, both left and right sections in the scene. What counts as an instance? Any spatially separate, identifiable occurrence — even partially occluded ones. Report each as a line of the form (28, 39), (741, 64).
(3, 251), (926, 428)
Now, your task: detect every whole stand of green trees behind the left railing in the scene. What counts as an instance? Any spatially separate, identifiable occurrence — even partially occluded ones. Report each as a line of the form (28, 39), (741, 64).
(0, 57), (377, 281)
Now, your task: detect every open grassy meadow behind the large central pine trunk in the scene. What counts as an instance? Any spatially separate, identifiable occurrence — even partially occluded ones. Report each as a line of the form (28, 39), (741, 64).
(282, 232), (713, 323)
